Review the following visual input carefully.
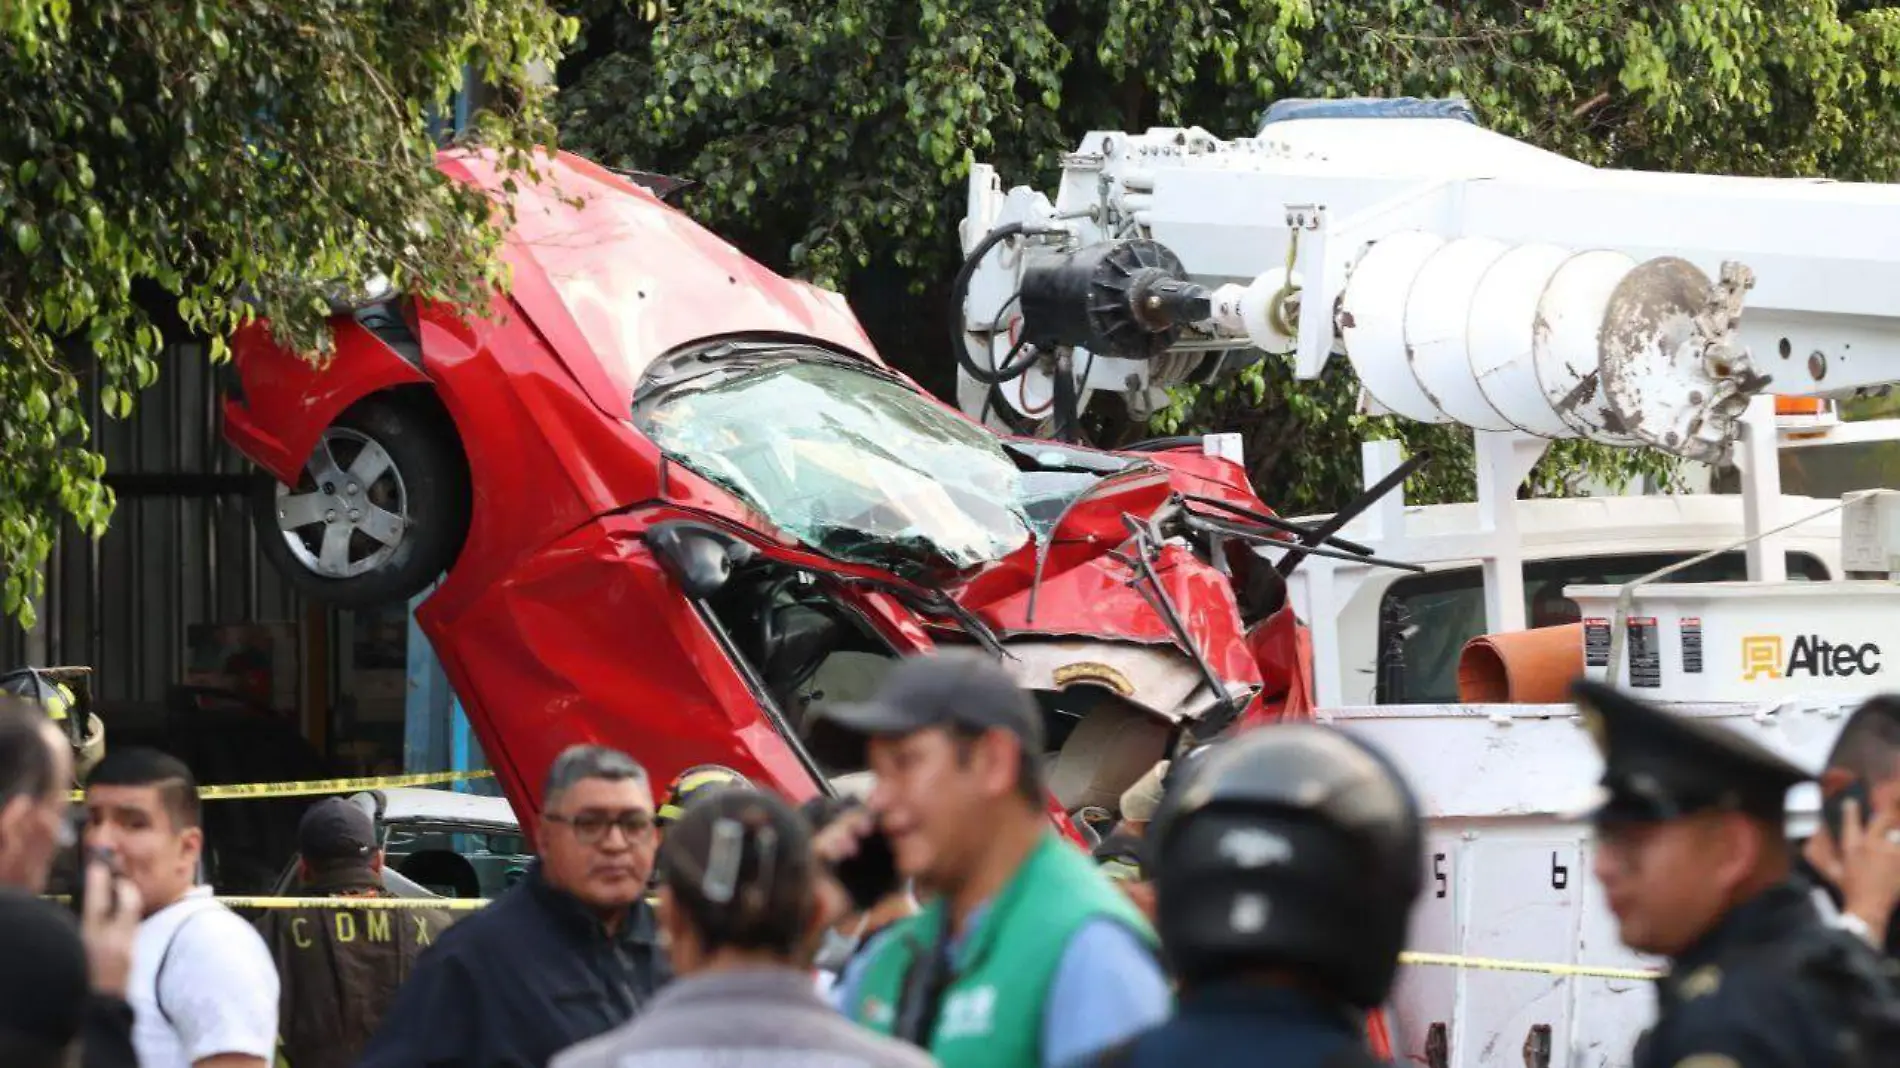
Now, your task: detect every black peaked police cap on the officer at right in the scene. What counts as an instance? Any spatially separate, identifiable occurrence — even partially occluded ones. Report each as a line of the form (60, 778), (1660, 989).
(1571, 678), (1813, 823)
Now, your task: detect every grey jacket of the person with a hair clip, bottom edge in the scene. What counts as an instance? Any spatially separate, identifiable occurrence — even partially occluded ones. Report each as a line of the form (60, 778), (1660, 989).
(549, 969), (937, 1068)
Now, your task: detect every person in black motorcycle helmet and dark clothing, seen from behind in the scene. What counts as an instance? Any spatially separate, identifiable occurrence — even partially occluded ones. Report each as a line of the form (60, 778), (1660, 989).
(1098, 724), (1425, 1068)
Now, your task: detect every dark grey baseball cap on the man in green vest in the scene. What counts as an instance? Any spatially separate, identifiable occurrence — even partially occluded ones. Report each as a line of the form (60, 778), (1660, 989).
(808, 650), (1043, 768)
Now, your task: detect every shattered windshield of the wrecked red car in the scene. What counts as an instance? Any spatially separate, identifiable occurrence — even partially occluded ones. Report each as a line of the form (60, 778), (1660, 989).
(635, 350), (1039, 570)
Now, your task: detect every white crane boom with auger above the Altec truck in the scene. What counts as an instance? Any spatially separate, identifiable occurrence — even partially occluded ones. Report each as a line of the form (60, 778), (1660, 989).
(958, 101), (1900, 462)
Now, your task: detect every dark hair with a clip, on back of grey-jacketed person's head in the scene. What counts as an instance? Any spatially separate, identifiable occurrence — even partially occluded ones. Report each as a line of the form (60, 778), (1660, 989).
(659, 787), (817, 958)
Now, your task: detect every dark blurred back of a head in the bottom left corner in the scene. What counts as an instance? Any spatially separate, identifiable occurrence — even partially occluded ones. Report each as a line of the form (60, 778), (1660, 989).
(0, 887), (89, 1055)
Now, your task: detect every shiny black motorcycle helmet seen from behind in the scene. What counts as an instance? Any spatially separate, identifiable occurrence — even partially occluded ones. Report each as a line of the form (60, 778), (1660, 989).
(1148, 724), (1425, 1009)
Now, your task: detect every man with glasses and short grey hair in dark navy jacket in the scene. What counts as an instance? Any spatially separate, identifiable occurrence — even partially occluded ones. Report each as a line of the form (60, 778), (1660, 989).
(359, 745), (669, 1068)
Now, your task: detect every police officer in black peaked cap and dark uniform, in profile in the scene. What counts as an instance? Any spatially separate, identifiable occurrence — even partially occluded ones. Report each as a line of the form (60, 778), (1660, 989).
(1575, 680), (1900, 1068)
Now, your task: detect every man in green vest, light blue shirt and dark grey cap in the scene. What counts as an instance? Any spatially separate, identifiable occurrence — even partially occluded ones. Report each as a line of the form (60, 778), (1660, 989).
(813, 652), (1172, 1068)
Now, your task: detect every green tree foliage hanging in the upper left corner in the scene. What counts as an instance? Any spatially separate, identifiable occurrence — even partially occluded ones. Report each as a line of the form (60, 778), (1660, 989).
(0, 0), (578, 625)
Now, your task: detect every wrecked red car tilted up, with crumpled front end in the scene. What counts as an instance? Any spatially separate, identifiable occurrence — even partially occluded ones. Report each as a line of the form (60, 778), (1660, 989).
(224, 152), (1307, 817)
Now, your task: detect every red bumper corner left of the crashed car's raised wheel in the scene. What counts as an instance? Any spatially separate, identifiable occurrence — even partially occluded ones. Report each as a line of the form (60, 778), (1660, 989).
(224, 319), (429, 485)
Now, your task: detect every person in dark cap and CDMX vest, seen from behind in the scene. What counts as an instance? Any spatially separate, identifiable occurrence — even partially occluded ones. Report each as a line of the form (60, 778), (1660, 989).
(257, 798), (456, 1068)
